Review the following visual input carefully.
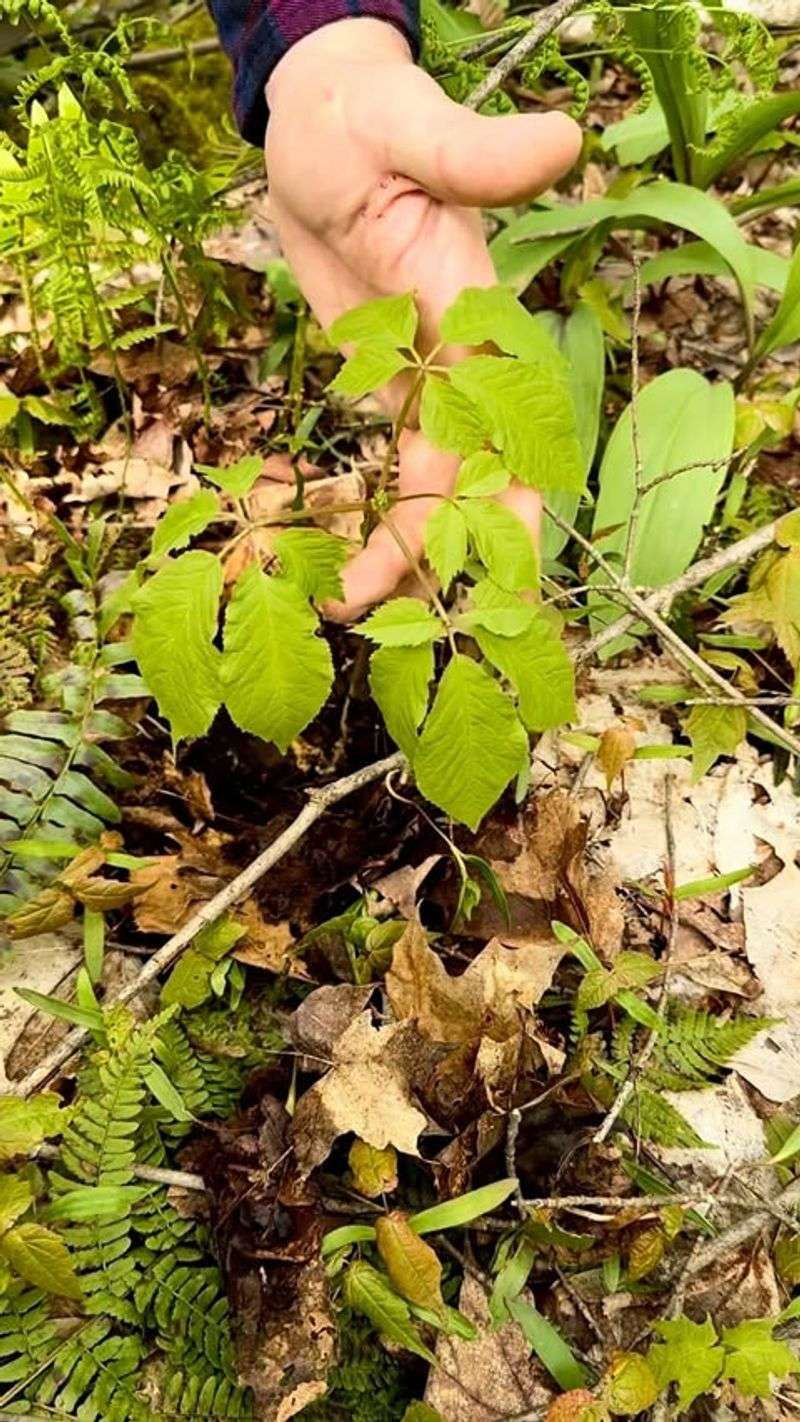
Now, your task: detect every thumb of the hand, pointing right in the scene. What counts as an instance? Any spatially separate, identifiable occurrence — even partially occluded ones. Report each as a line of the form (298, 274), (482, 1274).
(388, 70), (581, 208)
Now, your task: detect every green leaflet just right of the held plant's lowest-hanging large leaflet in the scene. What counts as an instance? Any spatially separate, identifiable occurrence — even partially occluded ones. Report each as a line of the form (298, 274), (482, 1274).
(475, 607), (575, 731)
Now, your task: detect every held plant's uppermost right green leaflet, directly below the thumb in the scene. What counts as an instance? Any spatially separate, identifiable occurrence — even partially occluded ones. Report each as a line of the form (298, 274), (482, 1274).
(439, 286), (558, 365)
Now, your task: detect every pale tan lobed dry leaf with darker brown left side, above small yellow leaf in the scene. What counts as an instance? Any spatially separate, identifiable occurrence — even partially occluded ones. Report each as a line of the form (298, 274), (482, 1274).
(291, 1012), (426, 1173)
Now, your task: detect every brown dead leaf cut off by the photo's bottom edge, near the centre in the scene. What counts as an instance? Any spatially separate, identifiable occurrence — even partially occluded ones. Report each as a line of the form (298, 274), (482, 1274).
(425, 1274), (553, 1422)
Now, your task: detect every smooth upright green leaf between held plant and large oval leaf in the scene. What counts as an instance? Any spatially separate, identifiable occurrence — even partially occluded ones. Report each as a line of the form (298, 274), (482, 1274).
(536, 301), (605, 560)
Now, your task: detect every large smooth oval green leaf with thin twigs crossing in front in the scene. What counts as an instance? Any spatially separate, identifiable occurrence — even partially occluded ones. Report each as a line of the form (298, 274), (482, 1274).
(591, 370), (735, 647)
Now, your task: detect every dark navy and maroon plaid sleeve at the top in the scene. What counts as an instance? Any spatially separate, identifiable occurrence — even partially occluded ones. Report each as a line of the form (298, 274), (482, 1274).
(209, 0), (419, 145)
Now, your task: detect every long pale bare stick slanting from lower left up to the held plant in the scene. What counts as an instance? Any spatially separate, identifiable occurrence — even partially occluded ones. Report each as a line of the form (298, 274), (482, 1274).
(10, 754), (405, 1096)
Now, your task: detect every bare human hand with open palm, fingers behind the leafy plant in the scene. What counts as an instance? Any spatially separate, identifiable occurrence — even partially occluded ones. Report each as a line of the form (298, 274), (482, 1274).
(266, 18), (581, 621)
